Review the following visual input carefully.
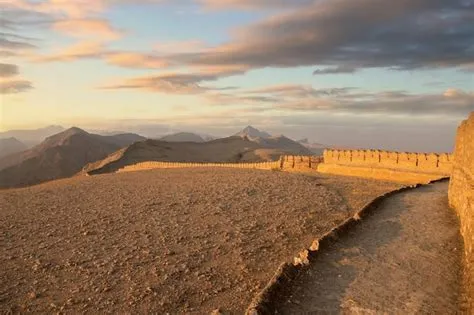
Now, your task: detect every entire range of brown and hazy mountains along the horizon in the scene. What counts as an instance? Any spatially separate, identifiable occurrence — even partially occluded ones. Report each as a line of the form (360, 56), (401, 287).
(0, 126), (322, 188)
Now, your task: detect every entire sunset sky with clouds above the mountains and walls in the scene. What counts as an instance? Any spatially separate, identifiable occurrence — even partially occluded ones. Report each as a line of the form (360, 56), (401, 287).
(0, 0), (474, 152)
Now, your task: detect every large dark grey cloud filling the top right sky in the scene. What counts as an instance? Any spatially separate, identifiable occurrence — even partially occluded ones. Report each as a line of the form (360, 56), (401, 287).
(162, 0), (474, 74)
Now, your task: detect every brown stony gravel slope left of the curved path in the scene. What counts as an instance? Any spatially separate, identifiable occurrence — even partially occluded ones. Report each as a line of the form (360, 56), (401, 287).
(0, 169), (398, 314)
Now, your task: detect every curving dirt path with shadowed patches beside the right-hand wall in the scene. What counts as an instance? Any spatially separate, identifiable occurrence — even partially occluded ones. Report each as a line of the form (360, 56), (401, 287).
(277, 182), (463, 314)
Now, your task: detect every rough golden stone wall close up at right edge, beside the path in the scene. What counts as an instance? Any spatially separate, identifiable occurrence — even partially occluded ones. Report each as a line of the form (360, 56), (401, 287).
(449, 112), (474, 314)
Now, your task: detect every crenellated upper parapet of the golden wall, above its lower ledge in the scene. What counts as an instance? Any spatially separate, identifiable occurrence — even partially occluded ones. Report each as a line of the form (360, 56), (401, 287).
(323, 150), (453, 176)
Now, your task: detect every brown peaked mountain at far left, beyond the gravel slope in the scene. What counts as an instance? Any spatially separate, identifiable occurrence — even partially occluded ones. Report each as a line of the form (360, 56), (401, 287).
(0, 127), (144, 188)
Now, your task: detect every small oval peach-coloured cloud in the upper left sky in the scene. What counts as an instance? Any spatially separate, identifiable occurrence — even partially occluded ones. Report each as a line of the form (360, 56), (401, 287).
(52, 19), (122, 40)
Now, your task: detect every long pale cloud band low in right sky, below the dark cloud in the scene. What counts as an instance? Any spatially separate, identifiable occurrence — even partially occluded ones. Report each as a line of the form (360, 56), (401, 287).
(210, 85), (474, 117)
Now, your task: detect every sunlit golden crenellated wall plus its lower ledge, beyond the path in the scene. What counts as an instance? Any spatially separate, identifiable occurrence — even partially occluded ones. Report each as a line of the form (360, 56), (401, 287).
(318, 150), (452, 183)
